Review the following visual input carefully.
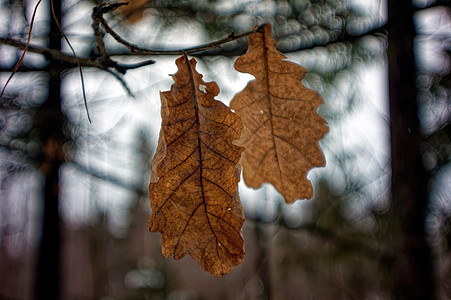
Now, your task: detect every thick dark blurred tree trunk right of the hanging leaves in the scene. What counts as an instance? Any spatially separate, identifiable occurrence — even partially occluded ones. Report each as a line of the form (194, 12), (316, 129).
(387, 0), (435, 299)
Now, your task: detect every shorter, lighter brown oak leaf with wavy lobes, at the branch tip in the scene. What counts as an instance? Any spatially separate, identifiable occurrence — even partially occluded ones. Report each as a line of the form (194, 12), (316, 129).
(230, 24), (328, 203)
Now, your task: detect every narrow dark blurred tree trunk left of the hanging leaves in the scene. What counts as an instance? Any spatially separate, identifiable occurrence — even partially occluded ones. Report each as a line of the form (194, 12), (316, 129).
(34, 1), (64, 299)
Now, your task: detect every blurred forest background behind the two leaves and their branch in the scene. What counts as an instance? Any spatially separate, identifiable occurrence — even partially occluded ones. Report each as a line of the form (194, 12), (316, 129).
(0, 0), (451, 299)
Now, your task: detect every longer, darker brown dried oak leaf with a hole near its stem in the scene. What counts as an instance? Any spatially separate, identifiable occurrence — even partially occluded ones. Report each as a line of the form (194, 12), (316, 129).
(148, 56), (244, 277)
